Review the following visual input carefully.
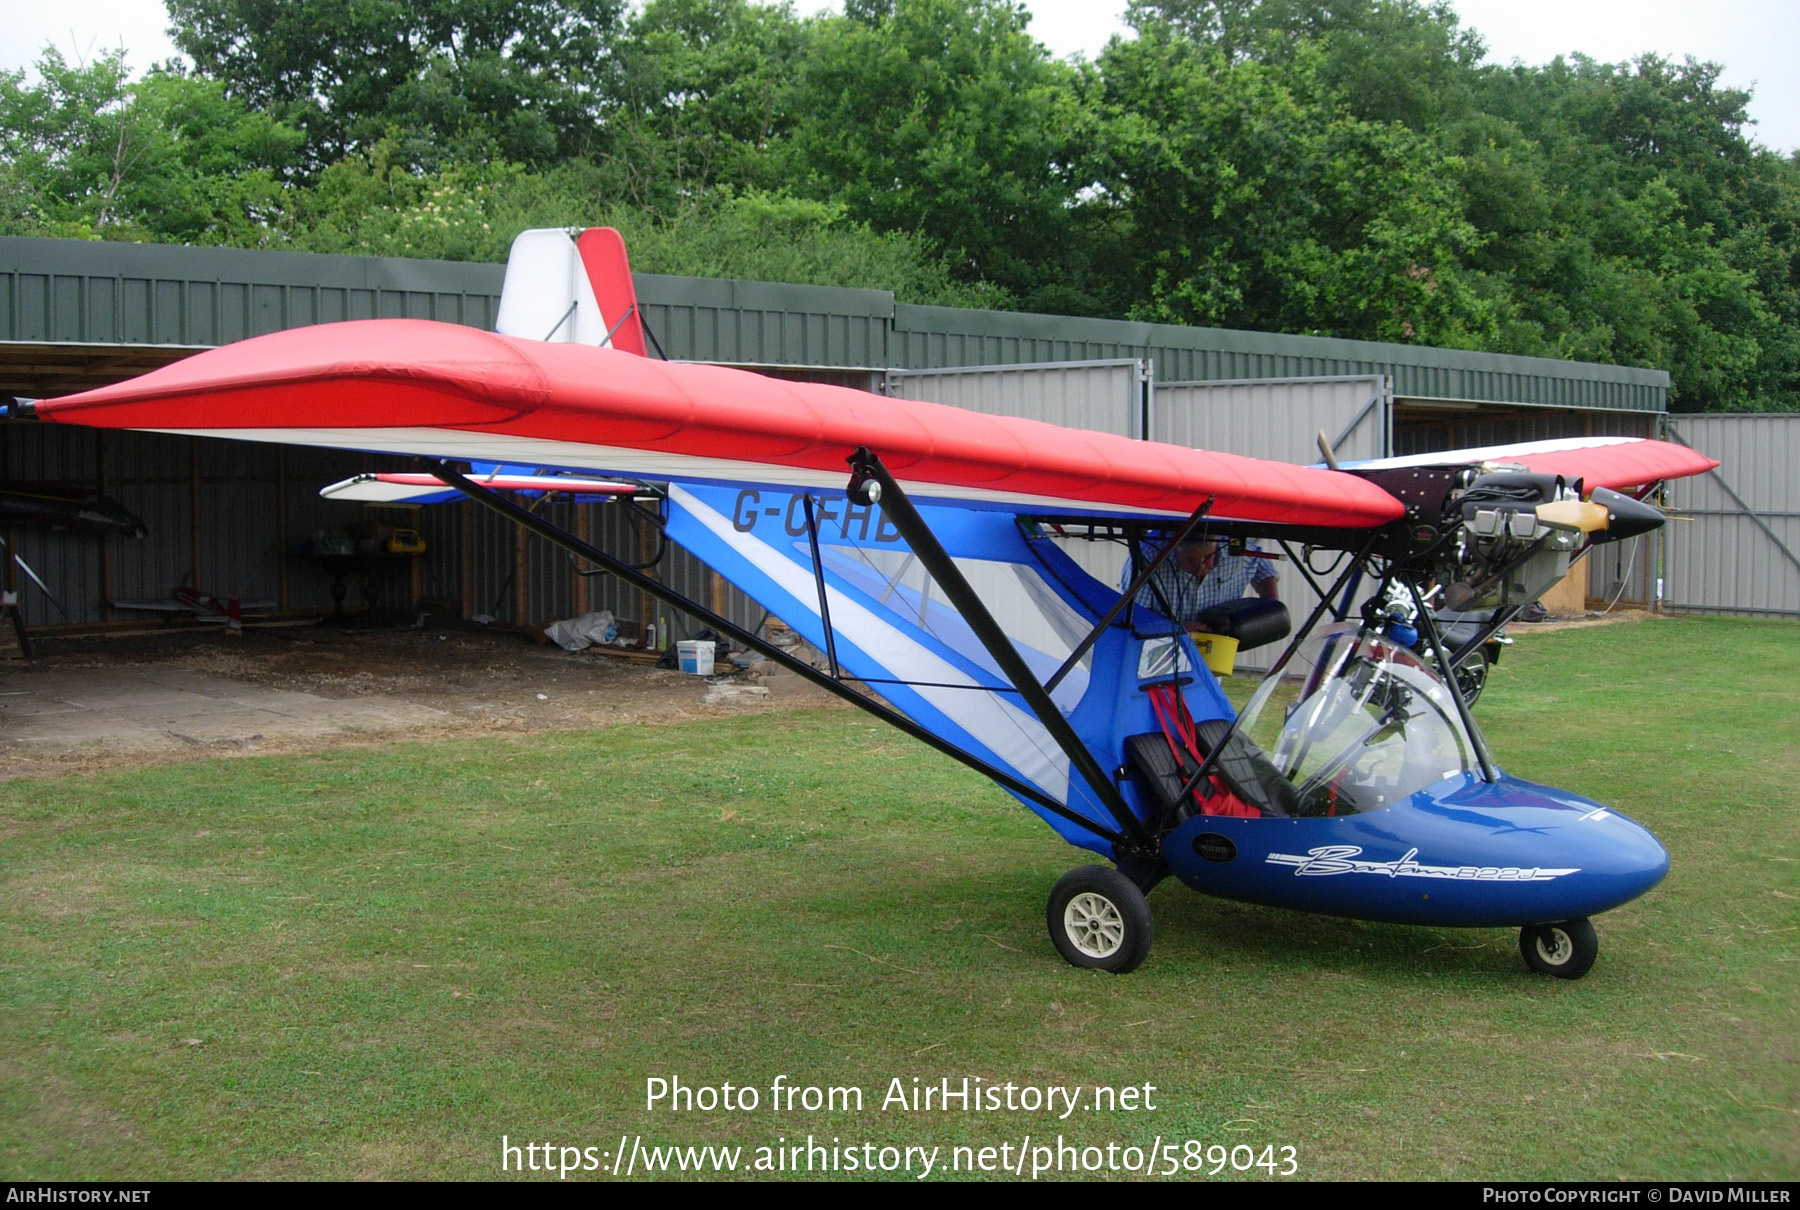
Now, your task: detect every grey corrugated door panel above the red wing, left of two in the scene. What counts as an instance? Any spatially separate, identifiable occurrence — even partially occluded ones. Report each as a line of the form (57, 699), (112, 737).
(886, 358), (1150, 438)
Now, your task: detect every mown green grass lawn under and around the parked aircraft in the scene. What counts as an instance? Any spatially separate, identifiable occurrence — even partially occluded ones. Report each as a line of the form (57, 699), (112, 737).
(0, 619), (1800, 1179)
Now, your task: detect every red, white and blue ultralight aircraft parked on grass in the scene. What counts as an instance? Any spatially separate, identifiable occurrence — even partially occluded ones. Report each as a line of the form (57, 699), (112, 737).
(21, 229), (1717, 978)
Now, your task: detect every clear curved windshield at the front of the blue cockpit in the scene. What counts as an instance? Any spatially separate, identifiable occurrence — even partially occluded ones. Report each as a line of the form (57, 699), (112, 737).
(1240, 625), (1474, 816)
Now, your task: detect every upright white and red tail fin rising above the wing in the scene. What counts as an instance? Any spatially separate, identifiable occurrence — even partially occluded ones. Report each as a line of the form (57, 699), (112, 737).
(495, 227), (646, 357)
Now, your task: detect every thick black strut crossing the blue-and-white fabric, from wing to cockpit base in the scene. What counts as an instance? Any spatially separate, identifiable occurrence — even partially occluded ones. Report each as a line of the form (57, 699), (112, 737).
(850, 447), (1157, 857)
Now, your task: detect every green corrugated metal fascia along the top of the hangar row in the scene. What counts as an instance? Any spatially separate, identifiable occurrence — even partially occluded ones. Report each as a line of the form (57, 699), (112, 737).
(0, 238), (1669, 412)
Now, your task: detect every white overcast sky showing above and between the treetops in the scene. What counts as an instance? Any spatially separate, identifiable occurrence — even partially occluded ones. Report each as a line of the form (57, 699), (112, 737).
(0, 0), (1800, 151)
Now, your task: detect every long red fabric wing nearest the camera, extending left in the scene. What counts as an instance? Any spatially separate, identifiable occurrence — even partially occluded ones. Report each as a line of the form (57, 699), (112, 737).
(38, 319), (1402, 528)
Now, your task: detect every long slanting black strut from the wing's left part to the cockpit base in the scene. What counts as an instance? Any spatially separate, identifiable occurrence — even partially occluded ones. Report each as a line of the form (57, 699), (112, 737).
(437, 461), (1127, 844)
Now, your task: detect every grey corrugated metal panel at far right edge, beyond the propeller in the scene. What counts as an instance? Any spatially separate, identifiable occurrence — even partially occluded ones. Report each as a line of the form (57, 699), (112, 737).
(1663, 414), (1800, 618)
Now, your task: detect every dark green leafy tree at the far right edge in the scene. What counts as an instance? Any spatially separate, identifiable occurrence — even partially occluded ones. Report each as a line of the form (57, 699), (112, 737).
(1440, 56), (1800, 411)
